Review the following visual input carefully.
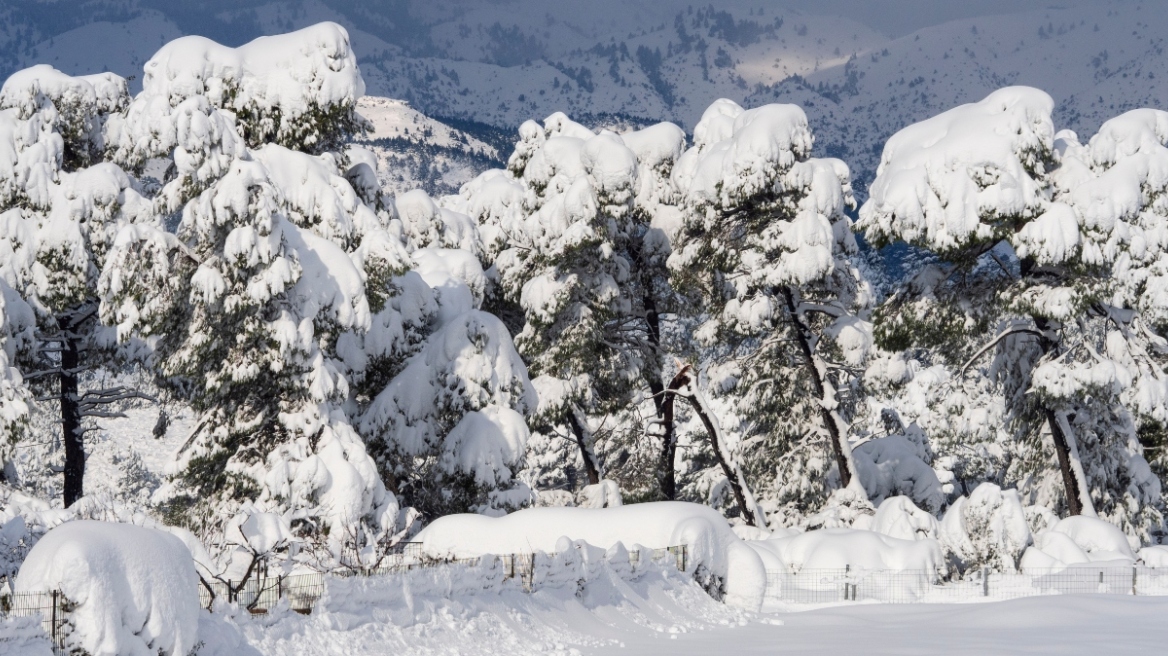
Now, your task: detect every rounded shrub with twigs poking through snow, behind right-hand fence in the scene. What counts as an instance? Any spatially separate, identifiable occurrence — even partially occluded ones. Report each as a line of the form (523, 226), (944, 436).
(938, 482), (1030, 572)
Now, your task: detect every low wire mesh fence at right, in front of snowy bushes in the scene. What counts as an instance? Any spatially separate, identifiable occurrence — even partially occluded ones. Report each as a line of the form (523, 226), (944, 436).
(766, 566), (1168, 603)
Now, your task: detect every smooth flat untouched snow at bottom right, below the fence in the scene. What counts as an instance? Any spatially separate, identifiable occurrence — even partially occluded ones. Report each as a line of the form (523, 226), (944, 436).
(602, 595), (1168, 656)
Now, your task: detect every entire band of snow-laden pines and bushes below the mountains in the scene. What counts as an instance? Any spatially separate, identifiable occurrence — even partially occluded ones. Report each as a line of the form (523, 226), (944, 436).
(0, 6), (1168, 656)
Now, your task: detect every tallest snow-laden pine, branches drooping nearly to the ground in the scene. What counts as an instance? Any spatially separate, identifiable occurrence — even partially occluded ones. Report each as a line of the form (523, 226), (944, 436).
(102, 23), (404, 539)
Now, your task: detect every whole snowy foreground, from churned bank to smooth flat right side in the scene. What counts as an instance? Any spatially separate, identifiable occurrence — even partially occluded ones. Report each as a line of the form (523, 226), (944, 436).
(193, 584), (1168, 656)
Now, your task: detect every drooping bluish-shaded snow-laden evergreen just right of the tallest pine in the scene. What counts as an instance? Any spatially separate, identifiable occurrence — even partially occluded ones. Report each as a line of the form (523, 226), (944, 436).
(360, 309), (537, 517)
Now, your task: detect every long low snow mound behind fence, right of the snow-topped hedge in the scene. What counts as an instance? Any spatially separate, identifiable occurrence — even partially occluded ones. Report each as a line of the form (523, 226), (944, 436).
(746, 529), (946, 574)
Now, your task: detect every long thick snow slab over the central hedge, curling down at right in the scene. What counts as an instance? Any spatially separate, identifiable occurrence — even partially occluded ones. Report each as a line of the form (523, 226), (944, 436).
(415, 502), (766, 608)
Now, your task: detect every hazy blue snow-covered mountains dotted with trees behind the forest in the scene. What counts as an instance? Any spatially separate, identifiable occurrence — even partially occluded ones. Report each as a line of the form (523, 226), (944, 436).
(9, 0), (1168, 190)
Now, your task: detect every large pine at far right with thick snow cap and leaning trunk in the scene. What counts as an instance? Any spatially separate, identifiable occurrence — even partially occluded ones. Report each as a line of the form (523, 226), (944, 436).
(861, 88), (1168, 540)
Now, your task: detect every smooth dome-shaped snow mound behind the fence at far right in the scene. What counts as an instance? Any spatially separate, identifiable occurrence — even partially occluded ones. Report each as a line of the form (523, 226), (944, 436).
(1022, 515), (1135, 571)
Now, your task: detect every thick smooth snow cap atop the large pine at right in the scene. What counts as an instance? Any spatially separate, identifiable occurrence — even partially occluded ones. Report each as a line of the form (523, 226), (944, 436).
(860, 86), (1055, 253)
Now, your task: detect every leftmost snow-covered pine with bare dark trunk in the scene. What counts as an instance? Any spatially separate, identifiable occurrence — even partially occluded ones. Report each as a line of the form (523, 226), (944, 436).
(0, 65), (162, 505)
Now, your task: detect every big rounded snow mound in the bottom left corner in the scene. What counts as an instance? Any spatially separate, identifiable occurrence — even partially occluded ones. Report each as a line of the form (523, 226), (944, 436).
(15, 521), (199, 656)
